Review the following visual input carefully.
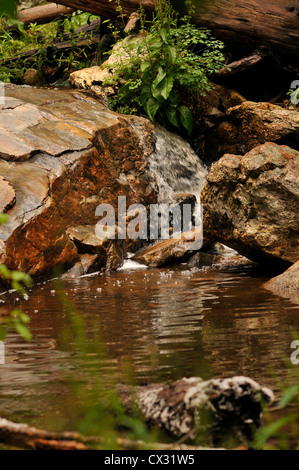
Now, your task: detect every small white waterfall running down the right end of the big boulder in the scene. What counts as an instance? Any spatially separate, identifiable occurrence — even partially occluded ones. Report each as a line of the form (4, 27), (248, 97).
(149, 125), (208, 203)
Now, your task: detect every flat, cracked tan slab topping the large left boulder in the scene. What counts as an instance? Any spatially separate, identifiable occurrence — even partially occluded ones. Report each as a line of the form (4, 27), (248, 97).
(0, 87), (117, 161)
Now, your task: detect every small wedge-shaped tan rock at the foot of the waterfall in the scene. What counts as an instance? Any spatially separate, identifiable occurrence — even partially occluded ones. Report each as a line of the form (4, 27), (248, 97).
(132, 229), (202, 268)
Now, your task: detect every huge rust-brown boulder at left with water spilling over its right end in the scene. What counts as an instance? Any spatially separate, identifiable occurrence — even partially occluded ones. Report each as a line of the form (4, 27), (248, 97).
(0, 85), (207, 277)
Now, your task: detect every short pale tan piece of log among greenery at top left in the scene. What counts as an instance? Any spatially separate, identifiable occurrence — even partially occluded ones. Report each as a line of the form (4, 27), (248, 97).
(18, 3), (75, 26)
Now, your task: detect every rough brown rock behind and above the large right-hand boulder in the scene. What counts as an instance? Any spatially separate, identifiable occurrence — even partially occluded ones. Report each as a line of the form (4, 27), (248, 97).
(208, 101), (299, 160)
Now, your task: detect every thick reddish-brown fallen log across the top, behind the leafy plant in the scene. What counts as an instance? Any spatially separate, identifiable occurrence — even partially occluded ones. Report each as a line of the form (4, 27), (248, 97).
(55, 0), (299, 63)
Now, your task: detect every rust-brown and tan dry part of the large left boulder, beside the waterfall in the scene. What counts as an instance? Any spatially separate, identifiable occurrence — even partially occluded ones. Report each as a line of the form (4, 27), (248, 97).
(0, 86), (157, 276)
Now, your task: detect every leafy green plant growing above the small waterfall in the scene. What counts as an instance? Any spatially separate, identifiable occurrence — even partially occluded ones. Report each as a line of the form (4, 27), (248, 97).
(105, 1), (223, 135)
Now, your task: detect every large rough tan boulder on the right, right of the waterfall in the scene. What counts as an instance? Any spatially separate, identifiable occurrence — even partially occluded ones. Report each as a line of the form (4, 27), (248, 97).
(201, 143), (299, 265)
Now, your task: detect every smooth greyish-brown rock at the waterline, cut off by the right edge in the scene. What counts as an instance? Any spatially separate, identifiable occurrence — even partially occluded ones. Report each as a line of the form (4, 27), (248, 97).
(264, 261), (299, 303)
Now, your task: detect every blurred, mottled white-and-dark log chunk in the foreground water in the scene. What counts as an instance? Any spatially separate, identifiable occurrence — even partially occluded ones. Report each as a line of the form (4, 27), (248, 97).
(120, 376), (274, 440)
